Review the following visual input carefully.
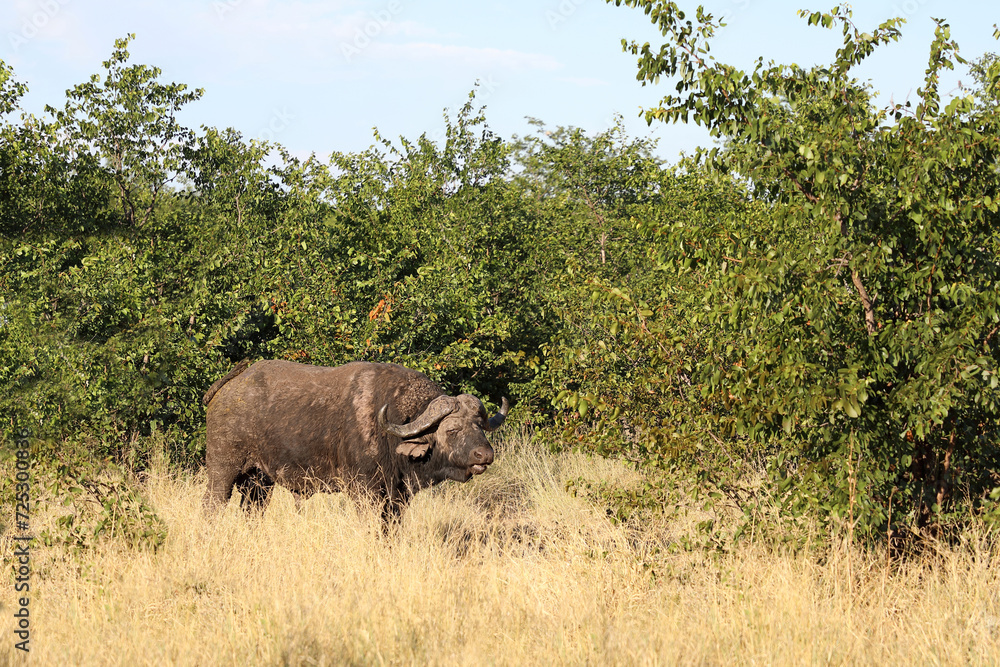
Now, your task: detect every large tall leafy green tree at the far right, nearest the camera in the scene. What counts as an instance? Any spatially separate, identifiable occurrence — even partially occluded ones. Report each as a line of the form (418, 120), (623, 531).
(584, 0), (1000, 537)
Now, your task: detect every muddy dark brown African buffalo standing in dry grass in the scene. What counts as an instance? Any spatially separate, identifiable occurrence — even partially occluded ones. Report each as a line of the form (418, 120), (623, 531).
(203, 360), (508, 516)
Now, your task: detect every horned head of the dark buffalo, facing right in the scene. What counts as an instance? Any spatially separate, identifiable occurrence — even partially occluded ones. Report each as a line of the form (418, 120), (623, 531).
(378, 394), (509, 484)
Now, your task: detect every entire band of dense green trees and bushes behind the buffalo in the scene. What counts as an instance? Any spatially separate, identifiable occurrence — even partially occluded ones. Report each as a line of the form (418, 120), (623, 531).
(0, 7), (1000, 545)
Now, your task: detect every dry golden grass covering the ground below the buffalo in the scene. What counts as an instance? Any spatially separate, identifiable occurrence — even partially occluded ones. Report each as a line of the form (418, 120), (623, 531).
(0, 430), (1000, 666)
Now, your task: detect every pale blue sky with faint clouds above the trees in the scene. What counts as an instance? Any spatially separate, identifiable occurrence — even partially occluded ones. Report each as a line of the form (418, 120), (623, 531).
(0, 0), (1000, 160)
